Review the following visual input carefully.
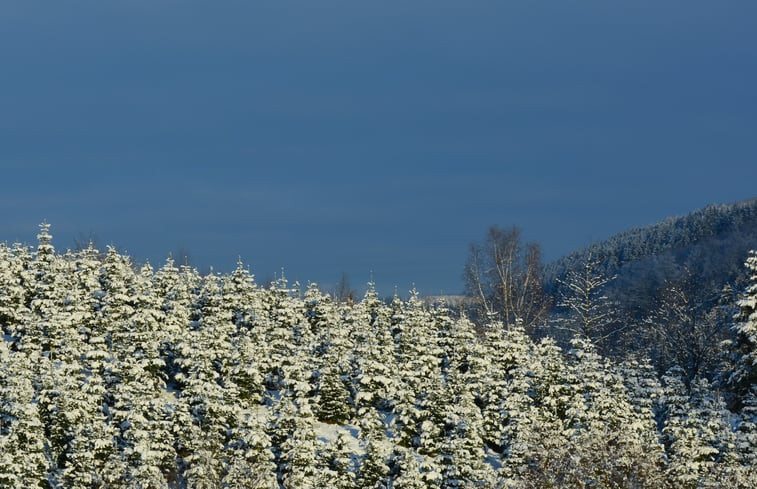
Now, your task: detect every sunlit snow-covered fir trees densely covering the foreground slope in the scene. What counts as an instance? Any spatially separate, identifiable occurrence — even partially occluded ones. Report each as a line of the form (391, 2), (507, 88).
(0, 224), (757, 489)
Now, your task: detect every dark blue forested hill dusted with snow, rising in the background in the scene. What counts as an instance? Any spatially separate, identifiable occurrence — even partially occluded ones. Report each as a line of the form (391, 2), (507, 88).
(545, 198), (757, 309)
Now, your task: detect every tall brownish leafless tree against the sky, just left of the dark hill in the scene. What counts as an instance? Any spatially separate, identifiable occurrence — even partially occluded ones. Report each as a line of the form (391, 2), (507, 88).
(464, 226), (549, 332)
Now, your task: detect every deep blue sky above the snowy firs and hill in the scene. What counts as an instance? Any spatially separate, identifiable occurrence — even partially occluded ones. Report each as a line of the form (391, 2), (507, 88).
(0, 0), (757, 295)
